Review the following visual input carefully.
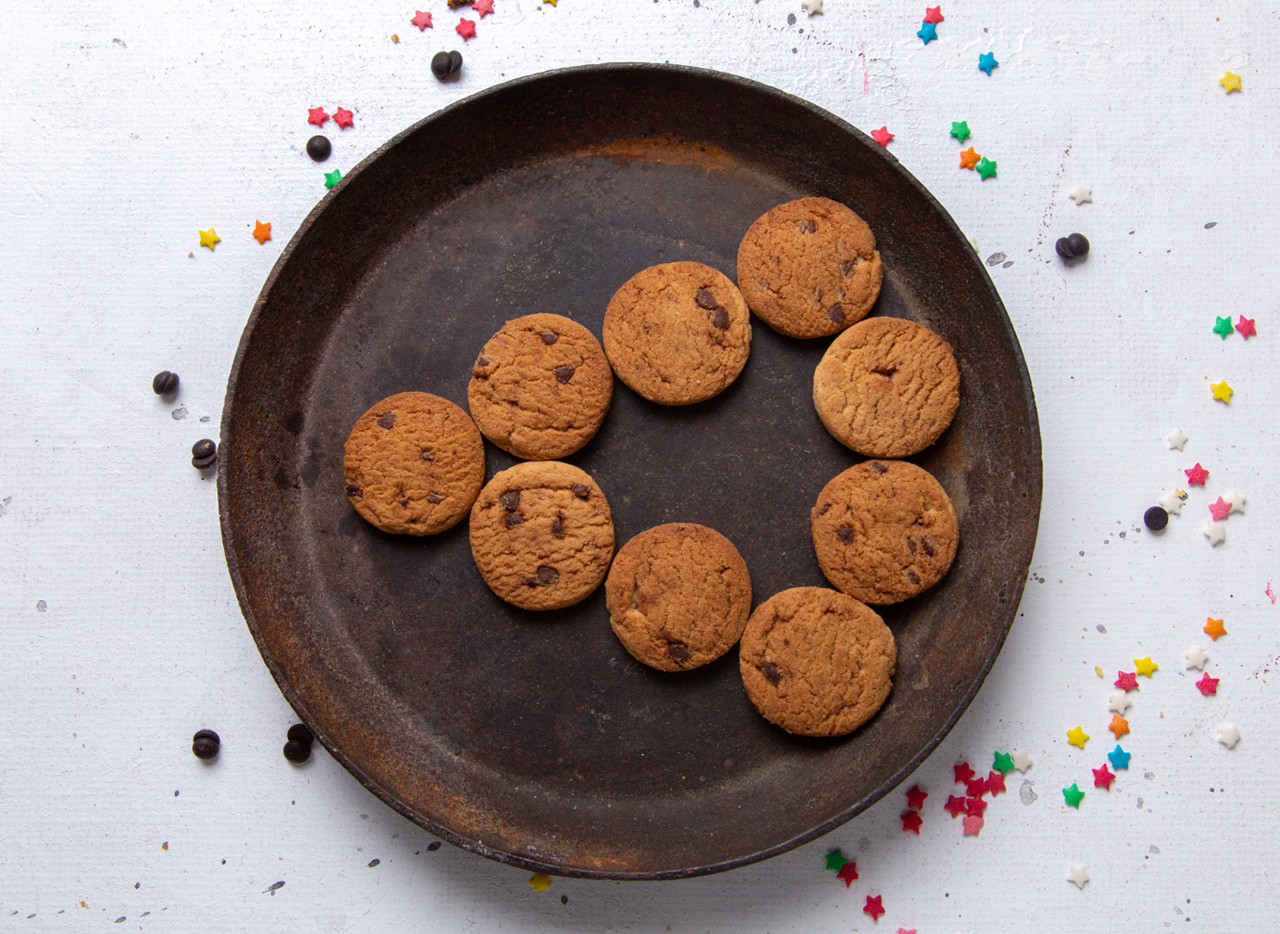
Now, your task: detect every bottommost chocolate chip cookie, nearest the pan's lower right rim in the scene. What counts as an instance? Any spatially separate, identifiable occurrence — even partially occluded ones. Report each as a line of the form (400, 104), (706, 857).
(739, 587), (897, 736)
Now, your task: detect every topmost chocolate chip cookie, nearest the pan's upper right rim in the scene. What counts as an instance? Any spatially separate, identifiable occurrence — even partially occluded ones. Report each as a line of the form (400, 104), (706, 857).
(737, 198), (883, 338)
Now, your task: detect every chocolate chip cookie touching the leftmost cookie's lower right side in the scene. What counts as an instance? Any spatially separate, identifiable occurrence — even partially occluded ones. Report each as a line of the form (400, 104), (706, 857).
(471, 461), (613, 610)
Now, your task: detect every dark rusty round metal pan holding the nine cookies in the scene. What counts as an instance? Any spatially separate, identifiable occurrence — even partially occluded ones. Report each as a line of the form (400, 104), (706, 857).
(218, 65), (1041, 879)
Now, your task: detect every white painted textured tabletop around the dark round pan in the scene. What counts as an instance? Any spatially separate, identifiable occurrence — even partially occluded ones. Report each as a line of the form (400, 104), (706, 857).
(0, 0), (1280, 934)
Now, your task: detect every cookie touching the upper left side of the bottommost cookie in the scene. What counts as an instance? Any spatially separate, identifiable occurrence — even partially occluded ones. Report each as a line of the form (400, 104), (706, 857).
(604, 522), (751, 672)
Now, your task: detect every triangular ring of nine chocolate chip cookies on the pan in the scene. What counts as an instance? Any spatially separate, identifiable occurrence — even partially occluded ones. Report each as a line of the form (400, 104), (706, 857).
(343, 197), (960, 737)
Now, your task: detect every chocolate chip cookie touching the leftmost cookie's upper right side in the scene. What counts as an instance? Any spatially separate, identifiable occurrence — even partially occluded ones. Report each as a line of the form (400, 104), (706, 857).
(467, 315), (613, 461)
